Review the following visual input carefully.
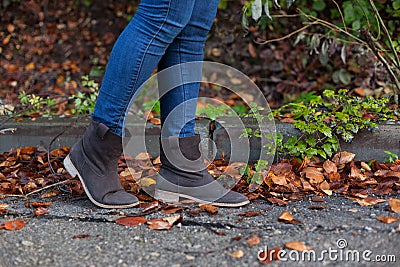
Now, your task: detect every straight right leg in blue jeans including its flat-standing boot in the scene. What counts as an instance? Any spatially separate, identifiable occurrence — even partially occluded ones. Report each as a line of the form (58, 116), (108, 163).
(155, 0), (249, 207)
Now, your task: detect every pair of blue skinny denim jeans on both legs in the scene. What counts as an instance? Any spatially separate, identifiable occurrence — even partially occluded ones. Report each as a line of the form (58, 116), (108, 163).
(92, 0), (219, 137)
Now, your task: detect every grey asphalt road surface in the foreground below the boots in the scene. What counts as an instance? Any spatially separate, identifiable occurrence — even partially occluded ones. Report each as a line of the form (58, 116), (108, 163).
(0, 196), (400, 267)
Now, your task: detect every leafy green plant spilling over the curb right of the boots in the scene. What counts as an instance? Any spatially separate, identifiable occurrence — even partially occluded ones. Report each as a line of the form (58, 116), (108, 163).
(275, 89), (394, 158)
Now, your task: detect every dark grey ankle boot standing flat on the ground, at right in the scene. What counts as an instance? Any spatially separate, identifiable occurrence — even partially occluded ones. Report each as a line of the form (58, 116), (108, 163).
(155, 135), (249, 207)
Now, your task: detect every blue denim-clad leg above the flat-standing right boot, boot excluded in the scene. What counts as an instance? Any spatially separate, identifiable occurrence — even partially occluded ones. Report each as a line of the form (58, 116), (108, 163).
(158, 0), (219, 138)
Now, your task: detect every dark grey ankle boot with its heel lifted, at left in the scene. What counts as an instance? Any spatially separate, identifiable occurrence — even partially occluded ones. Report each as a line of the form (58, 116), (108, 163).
(64, 121), (139, 209)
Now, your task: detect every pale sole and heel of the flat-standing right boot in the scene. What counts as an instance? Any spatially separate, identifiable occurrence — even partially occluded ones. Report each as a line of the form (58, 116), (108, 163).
(154, 189), (250, 208)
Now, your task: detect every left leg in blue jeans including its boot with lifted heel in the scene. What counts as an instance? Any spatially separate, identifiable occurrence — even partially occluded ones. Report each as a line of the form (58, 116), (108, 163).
(64, 0), (202, 208)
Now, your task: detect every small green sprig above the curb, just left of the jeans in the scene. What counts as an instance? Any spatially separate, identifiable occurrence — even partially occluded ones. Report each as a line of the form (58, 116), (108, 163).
(70, 75), (99, 114)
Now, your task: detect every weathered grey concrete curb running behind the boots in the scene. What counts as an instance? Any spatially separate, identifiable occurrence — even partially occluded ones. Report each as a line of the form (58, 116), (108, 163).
(0, 116), (400, 162)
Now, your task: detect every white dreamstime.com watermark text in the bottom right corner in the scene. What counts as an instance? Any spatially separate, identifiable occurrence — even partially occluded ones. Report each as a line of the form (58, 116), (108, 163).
(257, 238), (396, 262)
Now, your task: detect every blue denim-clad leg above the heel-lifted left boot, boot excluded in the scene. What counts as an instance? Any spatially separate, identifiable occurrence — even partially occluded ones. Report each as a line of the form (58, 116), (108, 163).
(93, 0), (195, 136)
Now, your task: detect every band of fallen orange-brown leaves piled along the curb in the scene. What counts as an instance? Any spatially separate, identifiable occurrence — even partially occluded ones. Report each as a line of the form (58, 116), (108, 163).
(0, 147), (400, 205)
